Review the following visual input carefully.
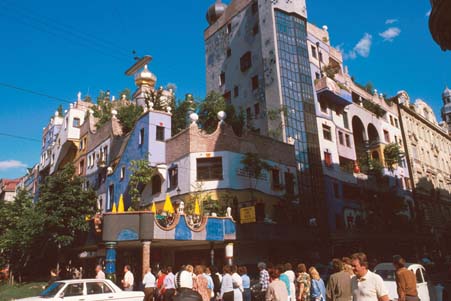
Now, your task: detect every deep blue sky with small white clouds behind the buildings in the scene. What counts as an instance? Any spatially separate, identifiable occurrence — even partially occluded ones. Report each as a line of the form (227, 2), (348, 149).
(0, 0), (451, 178)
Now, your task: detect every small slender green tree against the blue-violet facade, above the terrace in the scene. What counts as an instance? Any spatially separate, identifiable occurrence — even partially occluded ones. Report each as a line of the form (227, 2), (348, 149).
(128, 159), (157, 210)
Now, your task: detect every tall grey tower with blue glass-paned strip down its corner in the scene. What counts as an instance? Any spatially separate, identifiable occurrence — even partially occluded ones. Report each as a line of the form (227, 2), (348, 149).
(204, 0), (326, 229)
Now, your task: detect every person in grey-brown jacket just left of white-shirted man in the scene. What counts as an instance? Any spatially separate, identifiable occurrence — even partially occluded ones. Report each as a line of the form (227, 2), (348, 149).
(326, 258), (352, 301)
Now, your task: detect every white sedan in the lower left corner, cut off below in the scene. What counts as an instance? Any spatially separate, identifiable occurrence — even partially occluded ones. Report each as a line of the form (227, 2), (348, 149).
(17, 279), (144, 301)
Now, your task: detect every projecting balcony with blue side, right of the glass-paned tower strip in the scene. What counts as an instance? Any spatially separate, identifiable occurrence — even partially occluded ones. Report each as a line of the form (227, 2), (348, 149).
(315, 77), (352, 107)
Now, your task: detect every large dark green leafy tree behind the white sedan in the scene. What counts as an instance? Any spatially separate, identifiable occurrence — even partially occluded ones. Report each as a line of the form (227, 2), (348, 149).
(38, 164), (97, 248)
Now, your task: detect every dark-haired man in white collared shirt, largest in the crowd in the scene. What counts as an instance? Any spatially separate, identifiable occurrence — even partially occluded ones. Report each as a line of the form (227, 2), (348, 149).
(351, 253), (389, 301)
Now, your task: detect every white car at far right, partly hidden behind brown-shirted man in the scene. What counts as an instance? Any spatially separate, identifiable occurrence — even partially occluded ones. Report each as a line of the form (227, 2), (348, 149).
(374, 263), (431, 301)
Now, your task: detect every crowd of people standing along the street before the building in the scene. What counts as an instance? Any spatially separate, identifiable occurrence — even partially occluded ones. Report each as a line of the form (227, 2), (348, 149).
(46, 253), (419, 301)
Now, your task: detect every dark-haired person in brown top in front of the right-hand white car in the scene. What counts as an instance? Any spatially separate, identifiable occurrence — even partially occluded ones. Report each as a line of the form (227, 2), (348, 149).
(393, 255), (419, 301)
